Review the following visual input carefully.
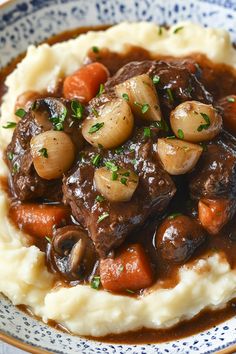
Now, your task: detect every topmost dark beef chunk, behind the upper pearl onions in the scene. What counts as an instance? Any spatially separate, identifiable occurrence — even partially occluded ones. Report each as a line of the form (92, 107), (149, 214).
(105, 60), (213, 118)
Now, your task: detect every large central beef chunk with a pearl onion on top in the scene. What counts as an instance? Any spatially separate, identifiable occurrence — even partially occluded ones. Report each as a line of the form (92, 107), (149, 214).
(63, 132), (175, 257)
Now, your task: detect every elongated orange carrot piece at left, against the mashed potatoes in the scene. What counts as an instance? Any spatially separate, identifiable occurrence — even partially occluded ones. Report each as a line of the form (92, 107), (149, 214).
(9, 204), (70, 237)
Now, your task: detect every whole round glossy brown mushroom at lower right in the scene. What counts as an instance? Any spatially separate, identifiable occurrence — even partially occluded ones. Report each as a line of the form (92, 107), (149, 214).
(156, 215), (206, 263)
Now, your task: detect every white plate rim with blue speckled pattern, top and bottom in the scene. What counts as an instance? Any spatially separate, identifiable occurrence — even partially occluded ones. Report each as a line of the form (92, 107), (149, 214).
(0, 0), (236, 354)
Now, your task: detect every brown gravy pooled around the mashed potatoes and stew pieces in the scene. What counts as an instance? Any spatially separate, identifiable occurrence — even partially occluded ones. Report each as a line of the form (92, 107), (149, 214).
(0, 26), (236, 344)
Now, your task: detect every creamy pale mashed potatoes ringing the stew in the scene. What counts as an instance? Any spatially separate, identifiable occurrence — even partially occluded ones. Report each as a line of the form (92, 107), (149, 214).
(0, 23), (236, 336)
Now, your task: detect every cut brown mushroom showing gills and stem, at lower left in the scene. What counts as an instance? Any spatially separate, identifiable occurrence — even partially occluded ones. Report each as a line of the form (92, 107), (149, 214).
(52, 225), (97, 280)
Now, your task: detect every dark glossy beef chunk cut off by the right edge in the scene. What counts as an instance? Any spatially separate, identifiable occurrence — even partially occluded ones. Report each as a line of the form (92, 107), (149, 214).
(189, 132), (236, 199)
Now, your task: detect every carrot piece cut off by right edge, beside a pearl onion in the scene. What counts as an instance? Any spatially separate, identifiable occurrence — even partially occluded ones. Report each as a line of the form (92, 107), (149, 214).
(219, 95), (236, 135)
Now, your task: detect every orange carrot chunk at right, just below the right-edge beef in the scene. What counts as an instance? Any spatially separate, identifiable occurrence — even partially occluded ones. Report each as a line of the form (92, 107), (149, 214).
(198, 199), (235, 235)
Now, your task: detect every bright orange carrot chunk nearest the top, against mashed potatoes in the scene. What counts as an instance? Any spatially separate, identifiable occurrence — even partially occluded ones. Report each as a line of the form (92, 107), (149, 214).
(63, 62), (109, 103)
